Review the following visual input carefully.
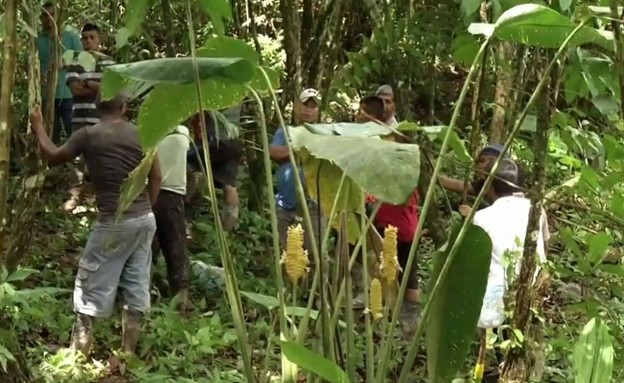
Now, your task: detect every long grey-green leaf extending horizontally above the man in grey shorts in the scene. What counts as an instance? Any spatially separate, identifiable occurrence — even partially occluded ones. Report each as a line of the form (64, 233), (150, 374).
(105, 57), (254, 84)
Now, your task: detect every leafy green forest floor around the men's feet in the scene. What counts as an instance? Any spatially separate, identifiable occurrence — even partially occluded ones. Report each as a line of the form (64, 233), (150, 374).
(8, 172), (621, 383)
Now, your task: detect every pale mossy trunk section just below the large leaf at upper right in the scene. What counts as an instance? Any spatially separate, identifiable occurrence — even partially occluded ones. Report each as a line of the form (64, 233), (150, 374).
(490, 42), (514, 144)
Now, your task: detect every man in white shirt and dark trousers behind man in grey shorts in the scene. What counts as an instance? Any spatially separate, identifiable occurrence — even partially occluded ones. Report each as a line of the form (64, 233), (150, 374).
(152, 126), (190, 305)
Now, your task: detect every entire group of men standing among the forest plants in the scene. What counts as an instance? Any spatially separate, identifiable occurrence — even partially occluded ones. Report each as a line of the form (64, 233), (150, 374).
(30, 4), (545, 354)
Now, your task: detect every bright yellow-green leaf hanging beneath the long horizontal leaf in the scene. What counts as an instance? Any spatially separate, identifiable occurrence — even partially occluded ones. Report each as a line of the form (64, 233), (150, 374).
(138, 79), (247, 150)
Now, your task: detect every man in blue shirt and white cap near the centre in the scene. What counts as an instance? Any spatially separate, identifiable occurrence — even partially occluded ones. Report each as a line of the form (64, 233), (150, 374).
(270, 89), (324, 252)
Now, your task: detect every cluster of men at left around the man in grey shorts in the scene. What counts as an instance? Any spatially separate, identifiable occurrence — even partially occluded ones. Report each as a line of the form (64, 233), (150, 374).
(30, 3), (242, 354)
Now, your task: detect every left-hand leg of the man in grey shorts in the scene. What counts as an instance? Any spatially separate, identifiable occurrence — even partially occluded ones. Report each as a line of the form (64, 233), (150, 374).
(71, 222), (140, 354)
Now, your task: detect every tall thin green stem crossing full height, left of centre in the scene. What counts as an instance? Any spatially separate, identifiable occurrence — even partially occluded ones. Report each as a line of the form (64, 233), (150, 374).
(186, 0), (256, 382)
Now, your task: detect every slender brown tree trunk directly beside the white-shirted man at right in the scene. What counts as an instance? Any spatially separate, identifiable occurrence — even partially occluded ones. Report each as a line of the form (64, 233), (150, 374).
(499, 52), (551, 383)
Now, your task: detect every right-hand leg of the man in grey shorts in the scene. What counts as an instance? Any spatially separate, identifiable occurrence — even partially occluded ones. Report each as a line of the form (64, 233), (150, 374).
(119, 213), (156, 353)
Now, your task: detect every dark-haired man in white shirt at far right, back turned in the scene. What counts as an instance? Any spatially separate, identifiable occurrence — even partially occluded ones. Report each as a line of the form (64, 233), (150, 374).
(473, 158), (547, 328)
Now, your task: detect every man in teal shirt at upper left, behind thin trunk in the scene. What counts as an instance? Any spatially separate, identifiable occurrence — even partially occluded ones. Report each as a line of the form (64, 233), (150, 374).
(37, 2), (82, 145)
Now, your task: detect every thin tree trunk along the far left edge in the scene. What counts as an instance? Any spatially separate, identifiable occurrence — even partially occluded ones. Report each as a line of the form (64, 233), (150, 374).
(0, 0), (17, 256)
